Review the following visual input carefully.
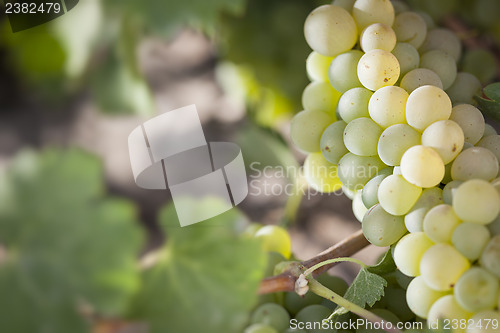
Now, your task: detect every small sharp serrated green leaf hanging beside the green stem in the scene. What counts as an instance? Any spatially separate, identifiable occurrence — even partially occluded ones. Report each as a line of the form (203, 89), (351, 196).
(334, 267), (387, 315)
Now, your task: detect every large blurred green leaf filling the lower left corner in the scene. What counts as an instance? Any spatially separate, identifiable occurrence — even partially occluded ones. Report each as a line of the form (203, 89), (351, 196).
(0, 150), (142, 333)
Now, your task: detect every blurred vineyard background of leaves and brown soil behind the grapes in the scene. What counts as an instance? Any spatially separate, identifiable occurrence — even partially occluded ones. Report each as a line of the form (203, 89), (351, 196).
(0, 0), (500, 333)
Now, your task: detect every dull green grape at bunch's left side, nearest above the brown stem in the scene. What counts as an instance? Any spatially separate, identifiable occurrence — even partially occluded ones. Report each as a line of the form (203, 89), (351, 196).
(362, 204), (406, 246)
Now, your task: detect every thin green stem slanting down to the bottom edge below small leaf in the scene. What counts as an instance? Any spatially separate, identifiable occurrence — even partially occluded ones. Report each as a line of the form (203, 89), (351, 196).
(306, 278), (402, 333)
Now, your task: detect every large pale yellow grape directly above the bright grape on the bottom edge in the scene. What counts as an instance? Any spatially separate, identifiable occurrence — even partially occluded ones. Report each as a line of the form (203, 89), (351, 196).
(420, 243), (470, 291)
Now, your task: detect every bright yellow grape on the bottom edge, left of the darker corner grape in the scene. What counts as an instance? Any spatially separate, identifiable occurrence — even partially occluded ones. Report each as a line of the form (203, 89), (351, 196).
(427, 295), (472, 333)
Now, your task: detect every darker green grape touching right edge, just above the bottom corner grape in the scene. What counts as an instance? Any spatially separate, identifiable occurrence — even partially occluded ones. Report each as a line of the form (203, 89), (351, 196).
(453, 267), (499, 312)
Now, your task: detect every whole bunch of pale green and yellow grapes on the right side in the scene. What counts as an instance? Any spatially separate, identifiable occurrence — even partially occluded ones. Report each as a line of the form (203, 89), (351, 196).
(290, 0), (500, 332)
